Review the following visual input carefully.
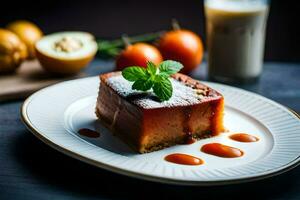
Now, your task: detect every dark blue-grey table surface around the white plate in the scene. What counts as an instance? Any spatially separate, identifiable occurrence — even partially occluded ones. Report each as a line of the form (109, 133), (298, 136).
(0, 60), (300, 199)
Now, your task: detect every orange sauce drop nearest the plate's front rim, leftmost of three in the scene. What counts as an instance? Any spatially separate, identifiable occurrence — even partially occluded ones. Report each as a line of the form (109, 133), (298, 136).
(165, 153), (203, 165)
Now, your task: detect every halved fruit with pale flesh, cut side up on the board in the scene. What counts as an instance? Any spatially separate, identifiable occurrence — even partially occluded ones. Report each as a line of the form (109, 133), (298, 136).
(35, 32), (97, 74)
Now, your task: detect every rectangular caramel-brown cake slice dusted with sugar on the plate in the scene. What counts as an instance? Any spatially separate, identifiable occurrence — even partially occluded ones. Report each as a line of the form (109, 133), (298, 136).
(96, 72), (224, 153)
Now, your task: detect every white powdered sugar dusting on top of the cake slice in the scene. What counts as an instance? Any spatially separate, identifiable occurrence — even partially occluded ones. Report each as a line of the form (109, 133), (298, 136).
(107, 75), (205, 109)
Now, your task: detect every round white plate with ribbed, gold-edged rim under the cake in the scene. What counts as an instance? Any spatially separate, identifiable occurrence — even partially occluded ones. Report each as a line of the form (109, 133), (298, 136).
(22, 77), (300, 185)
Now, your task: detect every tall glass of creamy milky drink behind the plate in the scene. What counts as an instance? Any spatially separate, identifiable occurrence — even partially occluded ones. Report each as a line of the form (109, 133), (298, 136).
(204, 0), (269, 82)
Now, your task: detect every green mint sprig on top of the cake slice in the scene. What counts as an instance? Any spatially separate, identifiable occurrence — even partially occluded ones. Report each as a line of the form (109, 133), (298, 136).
(122, 60), (183, 101)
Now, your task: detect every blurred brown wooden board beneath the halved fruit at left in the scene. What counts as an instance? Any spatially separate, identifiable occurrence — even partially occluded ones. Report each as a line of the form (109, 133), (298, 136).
(0, 60), (83, 102)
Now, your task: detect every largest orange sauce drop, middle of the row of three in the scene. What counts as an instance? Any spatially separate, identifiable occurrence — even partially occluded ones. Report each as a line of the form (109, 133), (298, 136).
(201, 143), (244, 158)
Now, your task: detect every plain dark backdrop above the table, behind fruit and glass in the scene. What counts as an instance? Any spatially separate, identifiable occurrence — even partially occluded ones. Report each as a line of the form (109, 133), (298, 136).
(0, 0), (300, 62)
